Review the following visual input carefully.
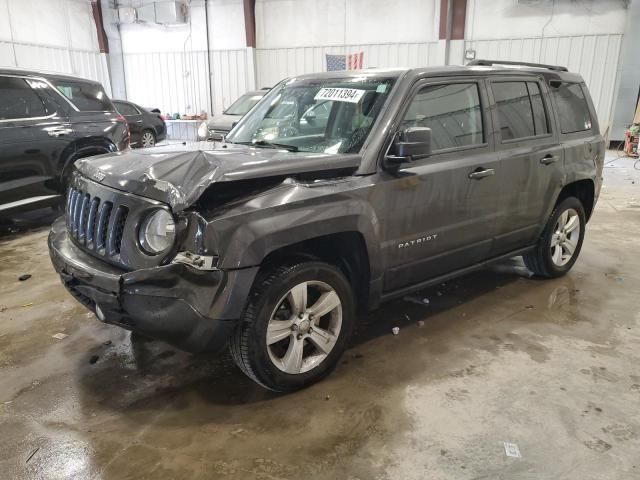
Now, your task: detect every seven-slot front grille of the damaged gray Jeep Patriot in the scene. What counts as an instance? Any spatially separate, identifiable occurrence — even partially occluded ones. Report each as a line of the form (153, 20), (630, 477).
(66, 187), (129, 257)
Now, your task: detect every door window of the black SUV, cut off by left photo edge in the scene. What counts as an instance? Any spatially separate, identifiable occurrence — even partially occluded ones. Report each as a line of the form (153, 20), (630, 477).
(0, 77), (53, 120)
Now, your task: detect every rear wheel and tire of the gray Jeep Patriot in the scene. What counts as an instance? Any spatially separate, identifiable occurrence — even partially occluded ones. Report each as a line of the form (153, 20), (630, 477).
(523, 197), (587, 278)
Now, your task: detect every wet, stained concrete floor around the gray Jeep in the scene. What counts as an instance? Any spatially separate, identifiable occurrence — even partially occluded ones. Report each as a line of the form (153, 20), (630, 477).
(0, 152), (640, 480)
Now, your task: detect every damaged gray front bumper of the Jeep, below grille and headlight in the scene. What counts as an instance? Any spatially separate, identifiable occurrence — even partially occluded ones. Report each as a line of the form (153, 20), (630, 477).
(48, 218), (258, 352)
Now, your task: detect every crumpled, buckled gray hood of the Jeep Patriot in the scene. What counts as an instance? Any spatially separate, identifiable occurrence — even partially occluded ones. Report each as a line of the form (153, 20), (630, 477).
(75, 142), (361, 212)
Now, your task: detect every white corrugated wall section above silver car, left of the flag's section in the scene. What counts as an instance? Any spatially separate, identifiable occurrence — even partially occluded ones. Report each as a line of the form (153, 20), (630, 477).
(124, 49), (253, 114)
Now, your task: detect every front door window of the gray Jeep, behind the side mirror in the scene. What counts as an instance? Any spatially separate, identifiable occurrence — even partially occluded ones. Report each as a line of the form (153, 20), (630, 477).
(400, 83), (484, 152)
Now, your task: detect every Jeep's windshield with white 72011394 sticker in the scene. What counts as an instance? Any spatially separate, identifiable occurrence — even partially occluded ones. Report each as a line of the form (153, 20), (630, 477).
(226, 76), (395, 153)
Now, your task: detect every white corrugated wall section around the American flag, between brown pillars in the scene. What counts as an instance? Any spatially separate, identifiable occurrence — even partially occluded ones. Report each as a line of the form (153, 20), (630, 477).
(256, 42), (444, 87)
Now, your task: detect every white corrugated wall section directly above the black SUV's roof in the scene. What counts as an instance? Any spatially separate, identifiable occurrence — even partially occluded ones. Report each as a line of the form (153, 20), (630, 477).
(0, 41), (111, 95)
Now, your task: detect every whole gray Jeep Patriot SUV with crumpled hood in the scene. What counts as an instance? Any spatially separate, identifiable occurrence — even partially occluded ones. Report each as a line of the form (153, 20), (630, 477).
(49, 61), (604, 391)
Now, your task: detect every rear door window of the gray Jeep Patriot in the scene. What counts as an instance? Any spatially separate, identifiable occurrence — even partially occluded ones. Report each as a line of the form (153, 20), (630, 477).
(492, 82), (549, 141)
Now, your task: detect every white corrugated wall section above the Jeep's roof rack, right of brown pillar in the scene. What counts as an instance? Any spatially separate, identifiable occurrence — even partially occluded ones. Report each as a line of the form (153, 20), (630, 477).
(465, 35), (622, 133)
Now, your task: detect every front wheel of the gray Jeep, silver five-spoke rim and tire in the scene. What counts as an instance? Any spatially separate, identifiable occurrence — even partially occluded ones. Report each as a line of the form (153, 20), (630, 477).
(229, 261), (356, 392)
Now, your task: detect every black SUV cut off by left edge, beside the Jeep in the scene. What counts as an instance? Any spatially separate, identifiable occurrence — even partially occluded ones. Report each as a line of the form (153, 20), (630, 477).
(0, 68), (129, 217)
